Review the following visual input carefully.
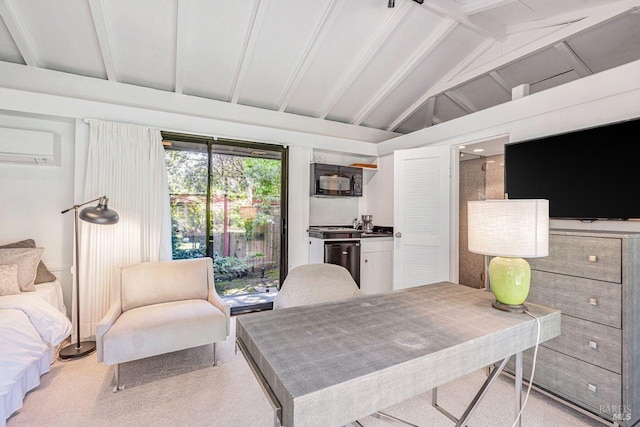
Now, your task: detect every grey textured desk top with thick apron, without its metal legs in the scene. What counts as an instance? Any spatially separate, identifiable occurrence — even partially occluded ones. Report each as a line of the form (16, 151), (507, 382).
(236, 282), (560, 427)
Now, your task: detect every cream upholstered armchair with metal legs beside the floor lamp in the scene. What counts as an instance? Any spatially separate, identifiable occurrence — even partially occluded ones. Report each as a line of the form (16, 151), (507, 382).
(96, 258), (231, 392)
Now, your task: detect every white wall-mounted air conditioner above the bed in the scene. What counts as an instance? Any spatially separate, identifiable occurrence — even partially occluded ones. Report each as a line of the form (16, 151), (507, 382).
(0, 127), (60, 166)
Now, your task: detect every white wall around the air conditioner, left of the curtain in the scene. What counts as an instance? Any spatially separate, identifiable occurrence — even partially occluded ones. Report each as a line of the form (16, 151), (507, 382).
(0, 111), (75, 313)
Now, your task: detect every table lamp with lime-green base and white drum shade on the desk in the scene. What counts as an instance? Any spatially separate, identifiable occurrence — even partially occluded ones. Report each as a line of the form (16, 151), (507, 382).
(468, 199), (549, 313)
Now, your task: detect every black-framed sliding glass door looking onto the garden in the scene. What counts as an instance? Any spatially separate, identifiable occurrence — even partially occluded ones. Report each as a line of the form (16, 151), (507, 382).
(163, 133), (287, 312)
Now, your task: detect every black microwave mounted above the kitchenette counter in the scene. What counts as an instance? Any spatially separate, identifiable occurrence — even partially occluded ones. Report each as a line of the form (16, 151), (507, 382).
(311, 163), (362, 197)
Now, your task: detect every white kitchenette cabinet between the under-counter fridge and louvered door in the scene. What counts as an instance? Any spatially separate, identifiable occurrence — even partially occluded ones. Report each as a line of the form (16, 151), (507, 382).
(360, 237), (393, 295)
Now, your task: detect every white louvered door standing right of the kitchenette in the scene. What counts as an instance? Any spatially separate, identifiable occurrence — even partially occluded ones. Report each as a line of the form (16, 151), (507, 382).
(393, 147), (451, 289)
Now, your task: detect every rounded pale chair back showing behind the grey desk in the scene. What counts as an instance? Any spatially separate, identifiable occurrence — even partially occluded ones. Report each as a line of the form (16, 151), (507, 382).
(273, 264), (364, 309)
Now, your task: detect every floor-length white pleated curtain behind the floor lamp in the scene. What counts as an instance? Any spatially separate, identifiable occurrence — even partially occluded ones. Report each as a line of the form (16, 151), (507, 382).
(73, 120), (171, 338)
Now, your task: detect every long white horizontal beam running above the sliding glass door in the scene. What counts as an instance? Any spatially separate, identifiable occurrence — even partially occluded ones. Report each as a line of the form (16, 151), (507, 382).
(0, 61), (398, 150)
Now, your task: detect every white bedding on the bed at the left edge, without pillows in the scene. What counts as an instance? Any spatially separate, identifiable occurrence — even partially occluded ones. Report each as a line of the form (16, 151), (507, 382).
(0, 279), (71, 427)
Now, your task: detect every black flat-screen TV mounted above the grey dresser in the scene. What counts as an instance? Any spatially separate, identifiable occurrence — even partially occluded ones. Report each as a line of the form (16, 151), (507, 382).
(504, 119), (640, 221)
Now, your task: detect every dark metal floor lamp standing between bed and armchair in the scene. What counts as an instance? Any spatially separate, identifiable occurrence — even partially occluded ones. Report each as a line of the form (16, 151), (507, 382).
(58, 196), (120, 360)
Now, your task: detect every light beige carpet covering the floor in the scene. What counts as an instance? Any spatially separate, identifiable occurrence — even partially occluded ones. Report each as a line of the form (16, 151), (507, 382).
(7, 317), (602, 427)
